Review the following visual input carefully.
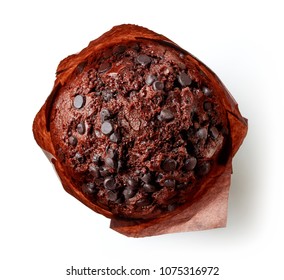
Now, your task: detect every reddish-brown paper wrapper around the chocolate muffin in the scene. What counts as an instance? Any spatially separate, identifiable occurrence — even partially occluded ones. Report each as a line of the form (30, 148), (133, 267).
(33, 25), (247, 237)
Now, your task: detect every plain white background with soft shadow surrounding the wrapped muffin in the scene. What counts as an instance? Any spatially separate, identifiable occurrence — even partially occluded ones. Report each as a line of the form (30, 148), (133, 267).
(0, 0), (284, 280)
